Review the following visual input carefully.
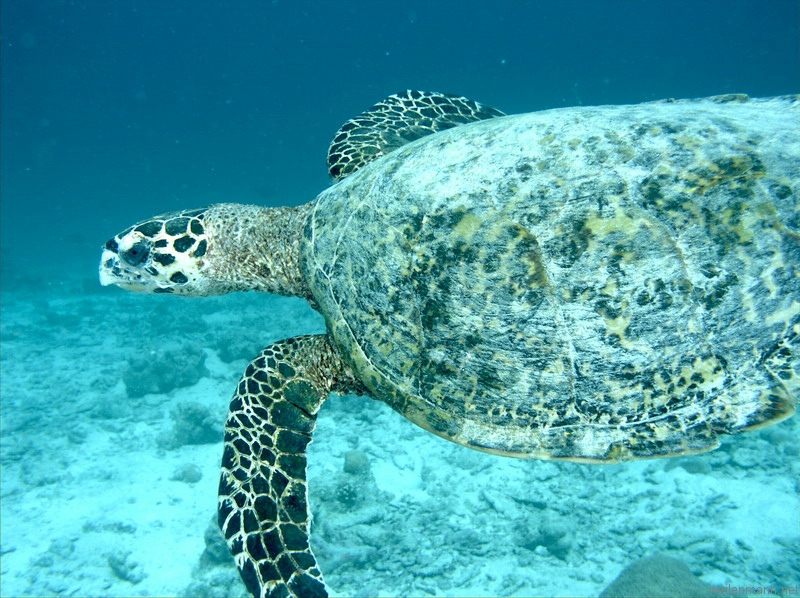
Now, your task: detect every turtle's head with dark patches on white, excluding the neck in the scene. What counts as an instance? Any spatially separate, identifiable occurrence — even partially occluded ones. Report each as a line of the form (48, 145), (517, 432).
(100, 208), (216, 295)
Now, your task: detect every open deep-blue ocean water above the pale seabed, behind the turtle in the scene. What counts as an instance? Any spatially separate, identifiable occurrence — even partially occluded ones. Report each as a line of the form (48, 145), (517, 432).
(2, 0), (800, 282)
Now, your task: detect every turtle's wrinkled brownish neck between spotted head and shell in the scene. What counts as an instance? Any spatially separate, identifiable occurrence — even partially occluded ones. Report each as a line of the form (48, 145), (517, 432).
(204, 204), (311, 299)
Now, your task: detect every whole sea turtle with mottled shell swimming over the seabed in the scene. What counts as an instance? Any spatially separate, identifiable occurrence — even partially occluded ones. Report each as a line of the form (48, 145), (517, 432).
(100, 91), (800, 596)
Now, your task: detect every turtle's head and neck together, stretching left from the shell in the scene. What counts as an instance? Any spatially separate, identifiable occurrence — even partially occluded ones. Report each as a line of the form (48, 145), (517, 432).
(100, 204), (310, 298)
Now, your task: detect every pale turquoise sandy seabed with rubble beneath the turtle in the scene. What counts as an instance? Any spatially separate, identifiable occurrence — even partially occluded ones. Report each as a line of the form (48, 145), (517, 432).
(0, 281), (800, 596)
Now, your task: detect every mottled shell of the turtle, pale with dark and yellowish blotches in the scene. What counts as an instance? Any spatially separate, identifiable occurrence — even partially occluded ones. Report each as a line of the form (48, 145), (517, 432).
(302, 96), (800, 461)
